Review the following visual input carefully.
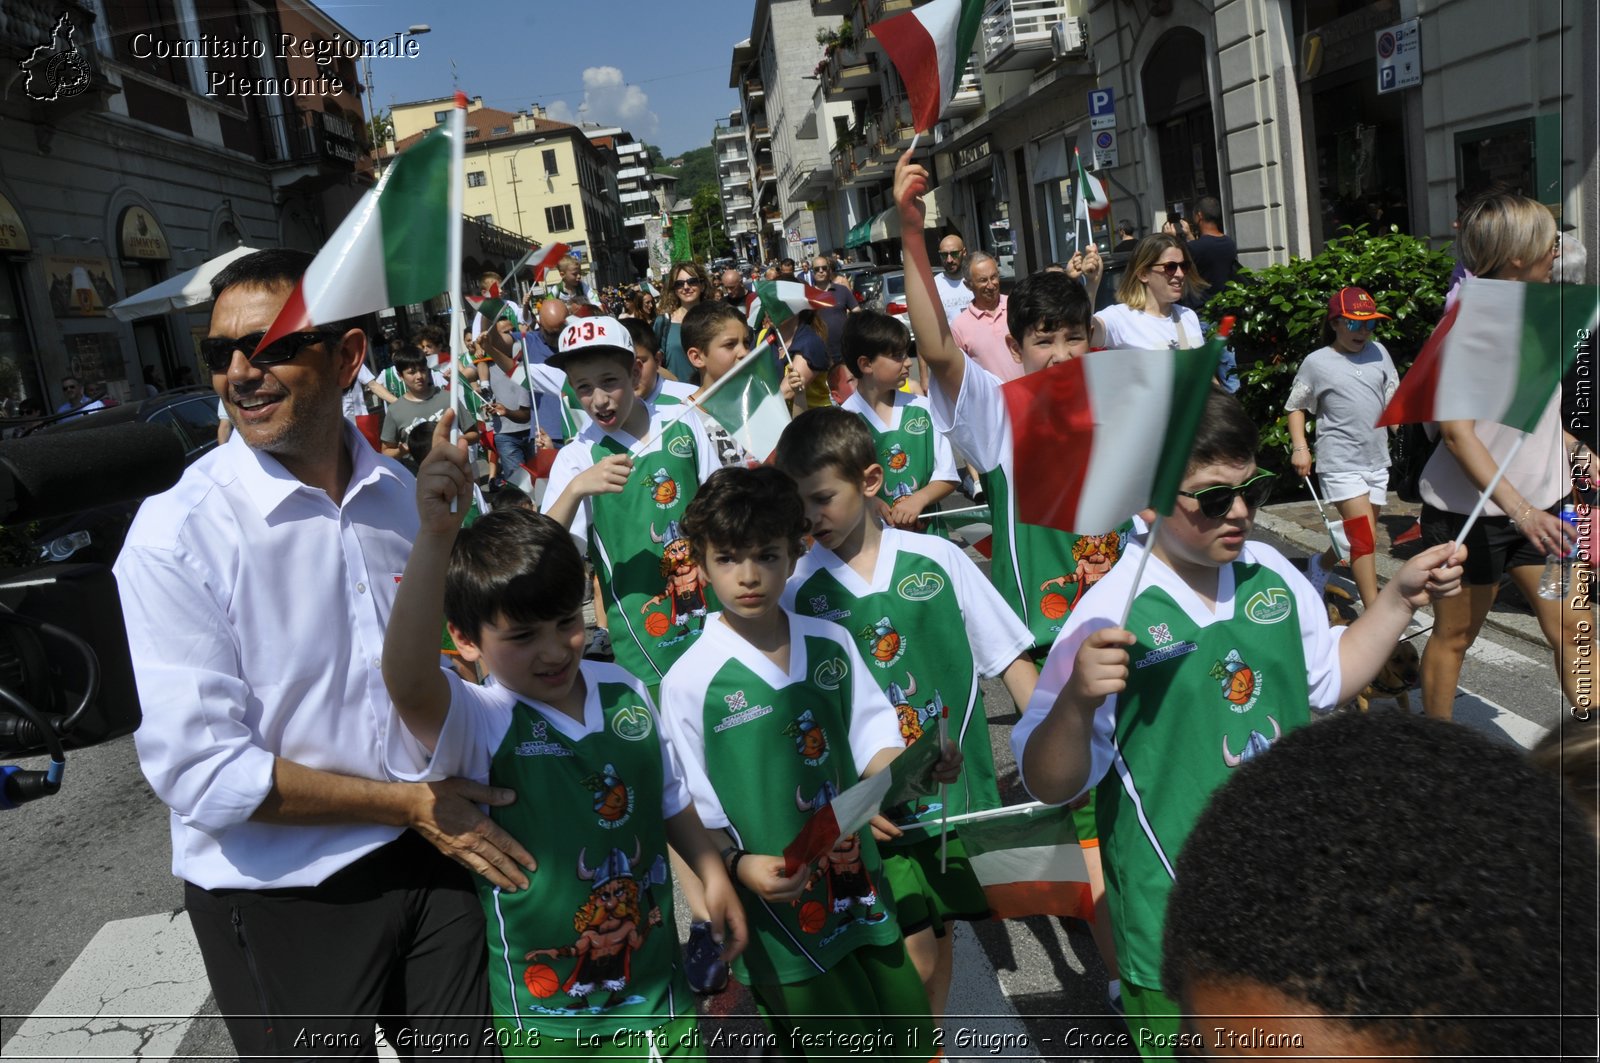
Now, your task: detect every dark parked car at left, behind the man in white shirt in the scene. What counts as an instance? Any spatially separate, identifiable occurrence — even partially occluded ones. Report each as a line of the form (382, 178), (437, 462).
(29, 386), (218, 565)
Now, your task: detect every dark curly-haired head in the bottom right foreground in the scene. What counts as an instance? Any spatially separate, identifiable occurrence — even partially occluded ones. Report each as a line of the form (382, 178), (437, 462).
(1162, 712), (1600, 1060)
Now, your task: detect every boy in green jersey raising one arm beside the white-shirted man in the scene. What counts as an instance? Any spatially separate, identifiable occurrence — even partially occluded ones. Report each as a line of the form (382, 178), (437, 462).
(382, 415), (746, 1058)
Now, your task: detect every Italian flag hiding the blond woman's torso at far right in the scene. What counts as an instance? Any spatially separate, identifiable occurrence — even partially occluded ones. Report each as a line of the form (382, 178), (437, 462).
(1378, 277), (1600, 432)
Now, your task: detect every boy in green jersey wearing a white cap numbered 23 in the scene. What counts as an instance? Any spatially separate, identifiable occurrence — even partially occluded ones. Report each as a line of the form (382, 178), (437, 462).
(544, 317), (717, 687)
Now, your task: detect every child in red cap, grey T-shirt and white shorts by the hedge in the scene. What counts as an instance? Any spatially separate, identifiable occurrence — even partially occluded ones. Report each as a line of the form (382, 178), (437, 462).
(1286, 288), (1400, 608)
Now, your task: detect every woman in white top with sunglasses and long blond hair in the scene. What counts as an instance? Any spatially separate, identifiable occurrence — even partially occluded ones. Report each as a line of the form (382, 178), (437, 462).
(1090, 234), (1206, 351)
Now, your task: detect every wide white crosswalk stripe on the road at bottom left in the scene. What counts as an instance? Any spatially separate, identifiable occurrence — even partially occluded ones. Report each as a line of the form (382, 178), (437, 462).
(5, 913), (211, 1060)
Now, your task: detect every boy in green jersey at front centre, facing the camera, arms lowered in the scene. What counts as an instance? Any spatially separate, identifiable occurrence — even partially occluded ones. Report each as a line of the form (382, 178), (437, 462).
(661, 466), (962, 1058)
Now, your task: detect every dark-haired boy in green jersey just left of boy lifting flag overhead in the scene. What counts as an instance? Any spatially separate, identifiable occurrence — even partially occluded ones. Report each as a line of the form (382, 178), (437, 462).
(832, 311), (960, 532)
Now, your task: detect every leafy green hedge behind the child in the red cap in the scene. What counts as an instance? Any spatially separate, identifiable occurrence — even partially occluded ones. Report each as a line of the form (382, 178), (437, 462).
(1202, 226), (1456, 495)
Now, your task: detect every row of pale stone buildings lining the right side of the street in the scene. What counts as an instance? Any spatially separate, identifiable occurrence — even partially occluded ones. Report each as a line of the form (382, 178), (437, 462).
(771, 0), (1600, 275)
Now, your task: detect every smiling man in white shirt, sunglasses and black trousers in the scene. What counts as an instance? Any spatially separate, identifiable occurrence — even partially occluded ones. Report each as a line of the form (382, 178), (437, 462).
(115, 251), (531, 1058)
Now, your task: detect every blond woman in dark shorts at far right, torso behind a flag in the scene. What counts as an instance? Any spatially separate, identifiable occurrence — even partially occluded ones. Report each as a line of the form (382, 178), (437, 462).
(1421, 192), (1594, 720)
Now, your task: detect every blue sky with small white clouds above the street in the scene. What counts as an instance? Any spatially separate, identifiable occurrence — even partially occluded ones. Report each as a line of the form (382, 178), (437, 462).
(320, 0), (755, 157)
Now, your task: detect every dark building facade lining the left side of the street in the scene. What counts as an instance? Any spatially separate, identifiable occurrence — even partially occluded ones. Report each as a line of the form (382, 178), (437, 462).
(0, 0), (371, 410)
